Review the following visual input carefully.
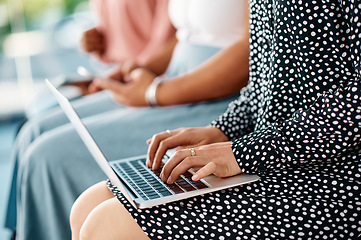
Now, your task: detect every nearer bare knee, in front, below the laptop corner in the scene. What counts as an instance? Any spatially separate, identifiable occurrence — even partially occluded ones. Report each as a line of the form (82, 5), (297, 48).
(80, 198), (149, 240)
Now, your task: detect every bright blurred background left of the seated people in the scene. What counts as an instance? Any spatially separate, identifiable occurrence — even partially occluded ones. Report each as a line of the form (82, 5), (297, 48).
(0, 0), (101, 239)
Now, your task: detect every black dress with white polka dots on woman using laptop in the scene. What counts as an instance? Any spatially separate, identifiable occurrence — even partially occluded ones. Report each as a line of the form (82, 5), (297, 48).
(108, 0), (361, 239)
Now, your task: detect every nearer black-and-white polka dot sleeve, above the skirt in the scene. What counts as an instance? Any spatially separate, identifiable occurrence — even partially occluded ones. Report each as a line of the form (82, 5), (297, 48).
(232, 79), (361, 175)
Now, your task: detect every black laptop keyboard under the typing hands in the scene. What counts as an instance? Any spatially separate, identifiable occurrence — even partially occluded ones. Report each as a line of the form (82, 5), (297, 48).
(113, 158), (208, 200)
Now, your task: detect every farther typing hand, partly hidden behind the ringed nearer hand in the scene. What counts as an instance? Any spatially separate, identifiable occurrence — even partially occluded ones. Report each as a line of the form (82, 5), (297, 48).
(147, 127), (228, 170)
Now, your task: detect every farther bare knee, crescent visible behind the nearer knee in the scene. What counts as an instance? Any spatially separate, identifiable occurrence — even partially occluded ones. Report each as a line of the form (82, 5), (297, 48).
(70, 182), (114, 239)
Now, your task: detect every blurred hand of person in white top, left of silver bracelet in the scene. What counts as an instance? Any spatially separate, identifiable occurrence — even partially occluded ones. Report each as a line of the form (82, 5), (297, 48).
(92, 68), (156, 107)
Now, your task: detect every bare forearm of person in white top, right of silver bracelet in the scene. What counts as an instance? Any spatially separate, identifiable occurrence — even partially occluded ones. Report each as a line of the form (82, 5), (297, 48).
(157, 34), (249, 106)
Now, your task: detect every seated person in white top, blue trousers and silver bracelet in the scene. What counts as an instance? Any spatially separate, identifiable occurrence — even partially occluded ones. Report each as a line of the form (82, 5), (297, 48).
(9, 0), (249, 239)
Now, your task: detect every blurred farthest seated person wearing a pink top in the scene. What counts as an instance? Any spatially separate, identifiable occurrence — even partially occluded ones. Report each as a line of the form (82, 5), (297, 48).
(25, 0), (175, 118)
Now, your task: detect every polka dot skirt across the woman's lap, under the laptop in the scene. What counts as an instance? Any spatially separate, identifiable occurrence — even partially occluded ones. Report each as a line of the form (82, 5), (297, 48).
(108, 156), (361, 239)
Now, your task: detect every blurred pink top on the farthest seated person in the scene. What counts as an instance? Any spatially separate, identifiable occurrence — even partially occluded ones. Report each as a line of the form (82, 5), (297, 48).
(90, 0), (175, 63)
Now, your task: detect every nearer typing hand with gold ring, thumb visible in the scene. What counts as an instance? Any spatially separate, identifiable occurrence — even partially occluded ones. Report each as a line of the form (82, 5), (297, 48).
(160, 142), (242, 184)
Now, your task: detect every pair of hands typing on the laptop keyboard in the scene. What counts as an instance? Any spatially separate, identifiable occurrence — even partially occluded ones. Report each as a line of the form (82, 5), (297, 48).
(147, 127), (242, 184)
